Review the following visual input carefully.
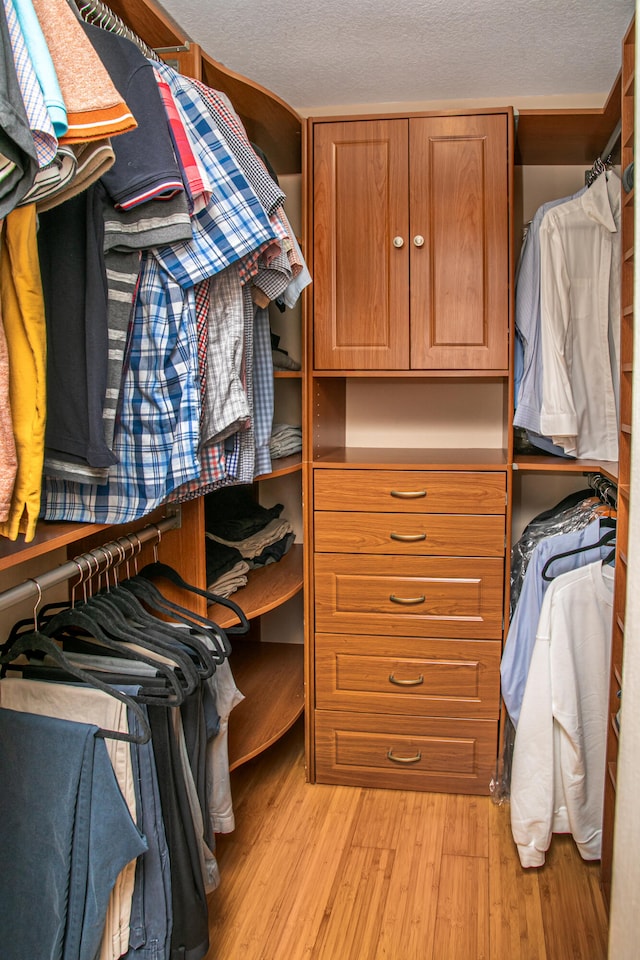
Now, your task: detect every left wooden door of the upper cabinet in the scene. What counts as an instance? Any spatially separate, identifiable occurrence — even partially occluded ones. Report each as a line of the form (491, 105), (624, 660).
(313, 120), (409, 370)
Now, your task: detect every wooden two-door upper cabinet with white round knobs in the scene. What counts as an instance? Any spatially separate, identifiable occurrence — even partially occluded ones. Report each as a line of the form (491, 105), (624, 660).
(312, 110), (511, 372)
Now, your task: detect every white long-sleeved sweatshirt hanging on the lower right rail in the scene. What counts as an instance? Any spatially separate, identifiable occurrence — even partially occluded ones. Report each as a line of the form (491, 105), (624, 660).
(511, 561), (613, 867)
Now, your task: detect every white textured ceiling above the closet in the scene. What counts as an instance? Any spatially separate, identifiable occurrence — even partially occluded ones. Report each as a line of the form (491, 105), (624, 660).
(156, 0), (635, 113)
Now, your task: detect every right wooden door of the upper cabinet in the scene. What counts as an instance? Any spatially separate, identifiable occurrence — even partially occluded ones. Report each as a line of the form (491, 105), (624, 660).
(409, 114), (509, 370)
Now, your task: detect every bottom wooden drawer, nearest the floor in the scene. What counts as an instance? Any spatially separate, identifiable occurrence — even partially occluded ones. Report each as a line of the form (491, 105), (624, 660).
(315, 710), (498, 794)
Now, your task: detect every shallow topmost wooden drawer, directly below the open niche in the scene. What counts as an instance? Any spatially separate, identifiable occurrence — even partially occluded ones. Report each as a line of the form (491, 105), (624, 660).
(313, 470), (507, 514)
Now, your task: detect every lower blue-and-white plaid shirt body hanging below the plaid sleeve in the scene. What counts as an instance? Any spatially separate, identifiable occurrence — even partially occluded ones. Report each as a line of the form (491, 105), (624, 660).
(42, 252), (200, 523)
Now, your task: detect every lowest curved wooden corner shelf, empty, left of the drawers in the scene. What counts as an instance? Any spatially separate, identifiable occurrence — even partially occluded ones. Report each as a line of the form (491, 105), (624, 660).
(229, 639), (304, 770)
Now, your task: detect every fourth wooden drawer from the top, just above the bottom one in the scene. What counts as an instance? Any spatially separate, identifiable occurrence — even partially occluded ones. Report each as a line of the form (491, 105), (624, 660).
(316, 633), (501, 720)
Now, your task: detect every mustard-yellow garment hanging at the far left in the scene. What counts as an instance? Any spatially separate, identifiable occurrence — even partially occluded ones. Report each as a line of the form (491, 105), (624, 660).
(0, 204), (47, 543)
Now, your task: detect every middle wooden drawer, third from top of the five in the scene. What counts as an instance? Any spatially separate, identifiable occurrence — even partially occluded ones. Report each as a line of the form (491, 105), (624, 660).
(315, 553), (504, 640)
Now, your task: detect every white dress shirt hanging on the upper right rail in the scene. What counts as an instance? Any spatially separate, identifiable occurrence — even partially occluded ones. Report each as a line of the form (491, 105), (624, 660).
(540, 171), (620, 460)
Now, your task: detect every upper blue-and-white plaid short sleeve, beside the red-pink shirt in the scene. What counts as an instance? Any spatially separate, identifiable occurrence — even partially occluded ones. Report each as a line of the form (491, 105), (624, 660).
(155, 64), (276, 288)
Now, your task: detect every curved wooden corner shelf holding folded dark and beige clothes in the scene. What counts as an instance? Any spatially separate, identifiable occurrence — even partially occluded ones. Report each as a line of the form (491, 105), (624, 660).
(207, 543), (303, 628)
